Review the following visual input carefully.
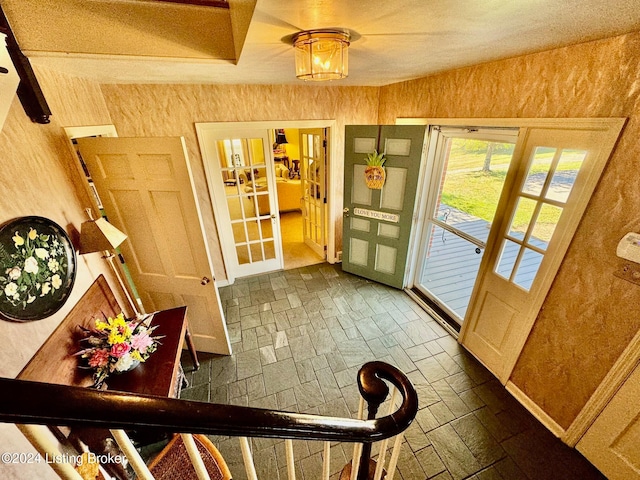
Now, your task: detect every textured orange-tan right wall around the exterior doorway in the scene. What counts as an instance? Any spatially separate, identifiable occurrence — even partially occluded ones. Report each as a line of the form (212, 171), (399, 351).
(379, 33), (640, 428)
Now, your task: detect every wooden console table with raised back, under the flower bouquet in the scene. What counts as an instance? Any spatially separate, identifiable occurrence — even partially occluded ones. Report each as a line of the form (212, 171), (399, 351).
(17, 275), (199, 479)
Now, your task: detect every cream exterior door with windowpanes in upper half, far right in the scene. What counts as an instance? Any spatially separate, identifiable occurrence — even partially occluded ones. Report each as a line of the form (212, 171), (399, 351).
(460, 119), (624, 383)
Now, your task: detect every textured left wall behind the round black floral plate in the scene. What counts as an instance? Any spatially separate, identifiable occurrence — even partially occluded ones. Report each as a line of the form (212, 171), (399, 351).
(0, 70), (117, 480)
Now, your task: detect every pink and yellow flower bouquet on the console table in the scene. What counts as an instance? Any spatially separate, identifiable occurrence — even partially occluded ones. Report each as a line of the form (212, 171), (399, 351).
(76, 313), (161, 388)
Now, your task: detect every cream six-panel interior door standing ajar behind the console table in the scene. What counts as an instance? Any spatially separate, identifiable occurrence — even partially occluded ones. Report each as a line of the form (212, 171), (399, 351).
(78, 137), (231, 354)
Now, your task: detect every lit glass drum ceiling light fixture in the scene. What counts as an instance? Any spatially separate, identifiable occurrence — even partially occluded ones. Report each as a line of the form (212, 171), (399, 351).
(293, 29), (350, 81)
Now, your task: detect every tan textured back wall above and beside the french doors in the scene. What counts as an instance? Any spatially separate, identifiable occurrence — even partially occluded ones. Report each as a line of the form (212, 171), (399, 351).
(102, 85), (379, 279)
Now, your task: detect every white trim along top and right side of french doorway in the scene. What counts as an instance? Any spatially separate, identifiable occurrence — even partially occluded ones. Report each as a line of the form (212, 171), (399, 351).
(195, 120), (342, 285)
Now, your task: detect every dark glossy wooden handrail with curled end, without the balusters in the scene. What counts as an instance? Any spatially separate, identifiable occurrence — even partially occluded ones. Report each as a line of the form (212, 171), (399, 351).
(0, 362), (418, 480)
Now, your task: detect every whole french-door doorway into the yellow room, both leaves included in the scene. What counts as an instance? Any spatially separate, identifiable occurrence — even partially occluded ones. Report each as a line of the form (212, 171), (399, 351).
(196, 120), (336, 283)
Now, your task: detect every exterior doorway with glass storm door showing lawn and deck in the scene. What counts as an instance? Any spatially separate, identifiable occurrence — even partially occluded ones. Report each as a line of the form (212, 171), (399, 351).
(414, 128), (518, 331)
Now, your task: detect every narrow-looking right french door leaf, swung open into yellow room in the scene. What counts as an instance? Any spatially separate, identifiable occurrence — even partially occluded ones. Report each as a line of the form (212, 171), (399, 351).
(299, 128), (328, 258)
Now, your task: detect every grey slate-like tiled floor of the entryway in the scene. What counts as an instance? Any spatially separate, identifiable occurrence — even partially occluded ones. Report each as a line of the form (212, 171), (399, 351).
(182, 263), (604, 480)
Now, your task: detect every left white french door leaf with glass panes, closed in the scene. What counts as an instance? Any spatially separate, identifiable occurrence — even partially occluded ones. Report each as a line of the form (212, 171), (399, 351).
(196, 124), (283, 281)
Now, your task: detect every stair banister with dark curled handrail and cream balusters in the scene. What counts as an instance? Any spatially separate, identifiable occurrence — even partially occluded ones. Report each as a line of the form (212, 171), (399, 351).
(0, 362), (418, 480)
